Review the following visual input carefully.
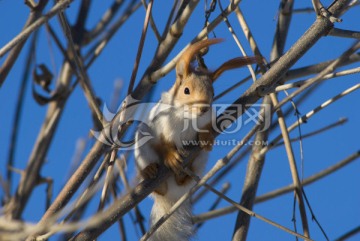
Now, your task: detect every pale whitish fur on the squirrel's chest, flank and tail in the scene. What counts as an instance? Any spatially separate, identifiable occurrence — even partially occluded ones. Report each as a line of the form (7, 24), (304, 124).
(135, 93), (211, 241)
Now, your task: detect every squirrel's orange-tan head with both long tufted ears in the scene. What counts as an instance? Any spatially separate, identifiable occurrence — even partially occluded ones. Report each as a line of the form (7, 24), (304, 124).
(170, 38), (259, 116)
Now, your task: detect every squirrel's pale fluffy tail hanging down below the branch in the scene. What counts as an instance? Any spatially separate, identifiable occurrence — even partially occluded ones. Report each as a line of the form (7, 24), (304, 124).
(149, 195), (193, 241)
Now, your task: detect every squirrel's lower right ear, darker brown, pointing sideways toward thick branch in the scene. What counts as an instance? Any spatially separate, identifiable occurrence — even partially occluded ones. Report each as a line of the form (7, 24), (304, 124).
(210, 56), (262, 82)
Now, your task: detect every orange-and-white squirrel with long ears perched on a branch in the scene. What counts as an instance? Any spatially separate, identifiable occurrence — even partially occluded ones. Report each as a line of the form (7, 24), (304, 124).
(134, 39), (258, 241)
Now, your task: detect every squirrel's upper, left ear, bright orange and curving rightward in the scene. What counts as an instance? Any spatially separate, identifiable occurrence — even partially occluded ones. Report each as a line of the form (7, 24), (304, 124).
(176, 38), (223, 78)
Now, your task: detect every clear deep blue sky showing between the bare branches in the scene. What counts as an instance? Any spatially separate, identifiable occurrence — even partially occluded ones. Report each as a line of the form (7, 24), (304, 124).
(0, 0), (360, 241)
